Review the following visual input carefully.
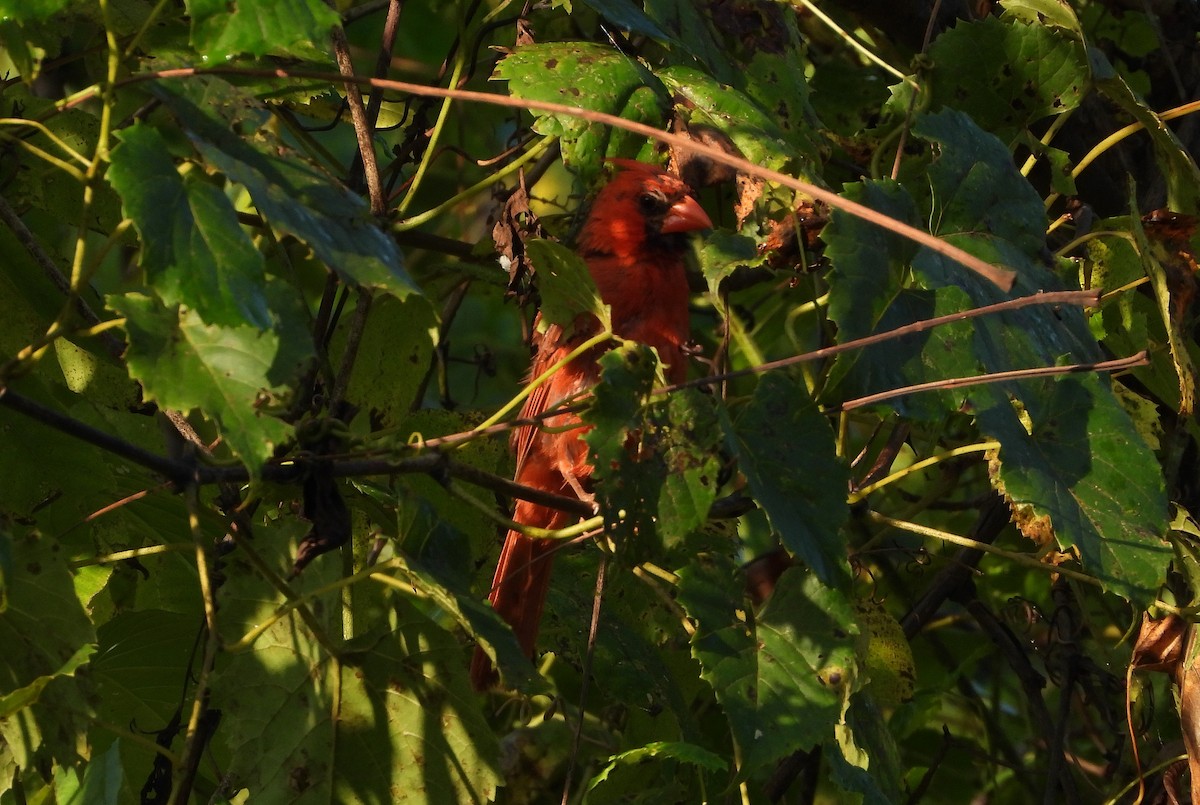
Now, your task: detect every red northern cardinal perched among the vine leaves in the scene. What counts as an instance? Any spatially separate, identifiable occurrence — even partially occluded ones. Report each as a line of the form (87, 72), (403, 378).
(470, 160), (713, 690)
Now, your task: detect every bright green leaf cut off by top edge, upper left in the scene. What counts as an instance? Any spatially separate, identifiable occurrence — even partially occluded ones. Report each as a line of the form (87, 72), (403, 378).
(187, 0), (342, 61)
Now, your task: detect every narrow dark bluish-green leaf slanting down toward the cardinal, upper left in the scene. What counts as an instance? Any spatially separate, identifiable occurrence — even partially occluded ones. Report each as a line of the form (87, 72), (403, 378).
(154, 82), (419, 299)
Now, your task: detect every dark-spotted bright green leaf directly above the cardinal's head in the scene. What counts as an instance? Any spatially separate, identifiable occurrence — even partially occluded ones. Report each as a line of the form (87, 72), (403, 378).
(493, 42), (666, 175)
